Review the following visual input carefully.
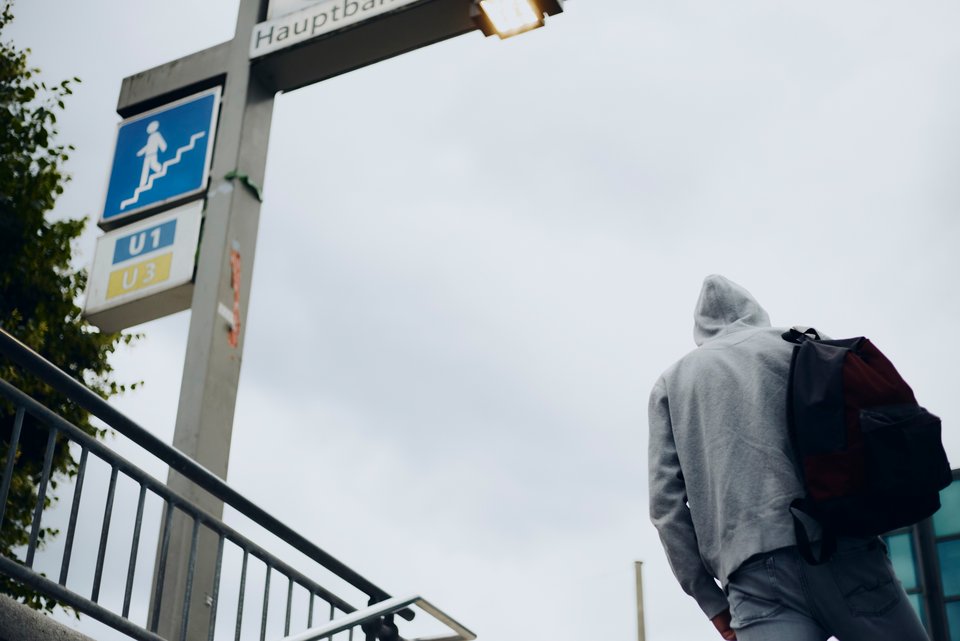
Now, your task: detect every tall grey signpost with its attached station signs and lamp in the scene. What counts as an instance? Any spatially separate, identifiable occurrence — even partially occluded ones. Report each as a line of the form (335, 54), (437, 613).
(86, 0), (562, 641)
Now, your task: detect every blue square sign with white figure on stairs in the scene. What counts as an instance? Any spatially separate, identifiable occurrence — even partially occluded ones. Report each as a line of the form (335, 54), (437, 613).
(99, 87), (220, 229)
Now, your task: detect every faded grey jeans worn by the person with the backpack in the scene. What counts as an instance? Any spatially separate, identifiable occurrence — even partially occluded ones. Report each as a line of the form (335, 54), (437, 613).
(727, 539), (928, 641)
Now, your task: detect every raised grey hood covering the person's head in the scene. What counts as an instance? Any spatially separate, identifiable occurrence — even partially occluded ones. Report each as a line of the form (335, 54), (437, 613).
(693, 274), (770, 345)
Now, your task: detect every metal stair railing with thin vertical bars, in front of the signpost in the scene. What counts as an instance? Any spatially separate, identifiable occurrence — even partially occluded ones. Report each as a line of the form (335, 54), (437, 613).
(0, 330), (475, 641)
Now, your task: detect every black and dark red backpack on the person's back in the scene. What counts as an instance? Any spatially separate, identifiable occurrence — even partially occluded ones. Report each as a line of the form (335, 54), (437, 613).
(783, 327), (952, 564)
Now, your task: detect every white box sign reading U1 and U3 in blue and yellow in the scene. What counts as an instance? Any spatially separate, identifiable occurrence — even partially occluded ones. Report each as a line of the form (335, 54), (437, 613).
(83, 201), (203, 332)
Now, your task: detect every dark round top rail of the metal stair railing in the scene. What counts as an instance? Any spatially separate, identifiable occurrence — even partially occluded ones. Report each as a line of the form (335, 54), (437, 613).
(0, 328), (414, 621)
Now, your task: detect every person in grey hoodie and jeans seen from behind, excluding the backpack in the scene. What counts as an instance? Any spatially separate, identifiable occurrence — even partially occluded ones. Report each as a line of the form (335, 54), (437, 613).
(649, 275), (927, 641)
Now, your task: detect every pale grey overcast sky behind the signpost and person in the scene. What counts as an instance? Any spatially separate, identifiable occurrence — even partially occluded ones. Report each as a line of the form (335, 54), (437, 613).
(3, 0), (960, 641)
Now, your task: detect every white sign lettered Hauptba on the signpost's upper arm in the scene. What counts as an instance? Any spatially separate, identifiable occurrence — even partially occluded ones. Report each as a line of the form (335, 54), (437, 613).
(250, 0), (421, 58)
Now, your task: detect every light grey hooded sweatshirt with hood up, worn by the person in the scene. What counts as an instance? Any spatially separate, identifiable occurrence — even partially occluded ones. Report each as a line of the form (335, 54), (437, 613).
(649, 275), (804, 618)
